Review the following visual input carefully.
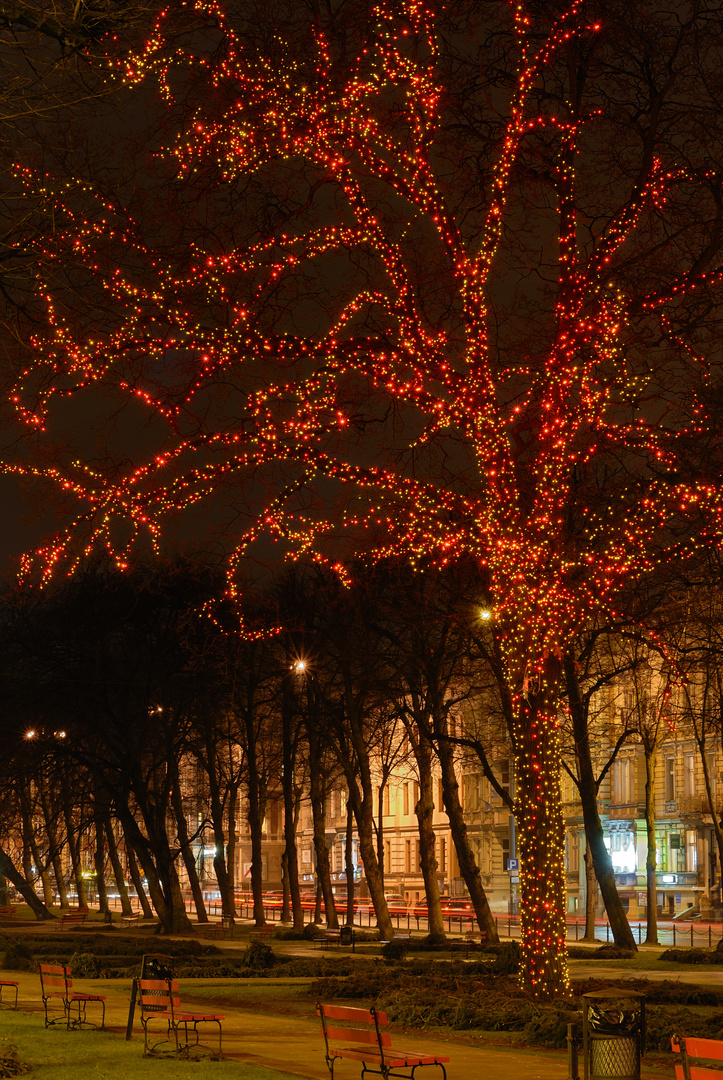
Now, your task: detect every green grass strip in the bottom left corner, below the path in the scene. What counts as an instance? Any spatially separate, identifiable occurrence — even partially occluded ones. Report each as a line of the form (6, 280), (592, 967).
(0, 1010), (298, 1080)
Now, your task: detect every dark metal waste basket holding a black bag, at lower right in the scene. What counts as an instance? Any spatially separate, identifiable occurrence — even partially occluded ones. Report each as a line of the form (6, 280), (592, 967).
(583, 988), (645, 1080)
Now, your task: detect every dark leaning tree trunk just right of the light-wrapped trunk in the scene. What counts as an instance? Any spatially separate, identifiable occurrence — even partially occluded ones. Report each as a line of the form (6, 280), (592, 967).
(564, 653), (638, 951)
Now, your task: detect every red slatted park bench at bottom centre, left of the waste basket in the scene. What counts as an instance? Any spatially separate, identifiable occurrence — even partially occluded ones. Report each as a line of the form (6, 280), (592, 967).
(317, 1002), (450, 1080)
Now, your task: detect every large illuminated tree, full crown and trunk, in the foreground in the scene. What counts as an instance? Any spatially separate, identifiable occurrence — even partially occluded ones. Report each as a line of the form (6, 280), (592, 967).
(11, 0), (723, 996)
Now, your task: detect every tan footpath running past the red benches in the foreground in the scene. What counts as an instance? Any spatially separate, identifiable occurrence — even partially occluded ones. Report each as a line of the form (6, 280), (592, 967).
(0, 972), (662, 1080)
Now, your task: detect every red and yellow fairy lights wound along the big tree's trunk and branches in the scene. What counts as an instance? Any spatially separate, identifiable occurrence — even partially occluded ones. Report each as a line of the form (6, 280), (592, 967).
(6, 0), (723, 996)
